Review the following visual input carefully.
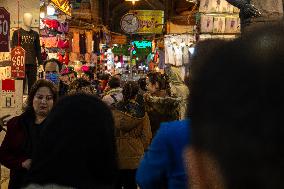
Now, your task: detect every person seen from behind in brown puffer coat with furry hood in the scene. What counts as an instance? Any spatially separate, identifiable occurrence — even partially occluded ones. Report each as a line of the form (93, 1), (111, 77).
(113, 81), (152, 189)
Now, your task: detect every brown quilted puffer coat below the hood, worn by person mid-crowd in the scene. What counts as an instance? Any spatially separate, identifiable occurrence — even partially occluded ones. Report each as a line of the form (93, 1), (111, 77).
(113, 110), (152, 169)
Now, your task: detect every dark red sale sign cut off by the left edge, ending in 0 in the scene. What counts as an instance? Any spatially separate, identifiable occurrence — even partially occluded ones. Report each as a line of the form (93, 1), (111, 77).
(0, 7), (10, 52)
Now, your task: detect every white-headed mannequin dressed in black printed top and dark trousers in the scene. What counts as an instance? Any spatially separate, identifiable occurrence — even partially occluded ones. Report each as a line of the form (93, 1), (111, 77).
(12, 13), (42, 94)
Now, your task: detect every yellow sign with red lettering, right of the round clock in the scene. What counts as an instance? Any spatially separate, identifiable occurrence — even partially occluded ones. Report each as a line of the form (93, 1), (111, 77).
(130, 10), (164, 34)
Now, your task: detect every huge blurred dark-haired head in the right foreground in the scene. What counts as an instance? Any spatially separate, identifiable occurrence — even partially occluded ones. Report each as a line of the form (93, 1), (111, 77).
(190, 23), (284, 189)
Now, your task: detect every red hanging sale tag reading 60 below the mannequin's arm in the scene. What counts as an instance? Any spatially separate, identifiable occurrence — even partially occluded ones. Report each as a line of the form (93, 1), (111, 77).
(11, 46), (26, 78)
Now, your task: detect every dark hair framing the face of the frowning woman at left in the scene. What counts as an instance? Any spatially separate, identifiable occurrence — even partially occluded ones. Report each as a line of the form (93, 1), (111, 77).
(25, 79), (58, 113)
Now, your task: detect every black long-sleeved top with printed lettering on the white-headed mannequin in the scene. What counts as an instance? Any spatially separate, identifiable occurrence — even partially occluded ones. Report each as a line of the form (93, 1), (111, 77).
(12, 28), (42, 65)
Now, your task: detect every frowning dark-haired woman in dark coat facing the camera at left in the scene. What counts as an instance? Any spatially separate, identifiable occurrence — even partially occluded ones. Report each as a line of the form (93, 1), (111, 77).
(0, 80), (57, 189)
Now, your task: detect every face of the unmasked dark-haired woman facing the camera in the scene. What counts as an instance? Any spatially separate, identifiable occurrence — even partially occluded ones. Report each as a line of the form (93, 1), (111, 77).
(33, 87), (53, 117)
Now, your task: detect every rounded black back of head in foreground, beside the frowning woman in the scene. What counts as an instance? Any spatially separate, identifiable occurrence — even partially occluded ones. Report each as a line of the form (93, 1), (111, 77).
(27, 94), (117, 189)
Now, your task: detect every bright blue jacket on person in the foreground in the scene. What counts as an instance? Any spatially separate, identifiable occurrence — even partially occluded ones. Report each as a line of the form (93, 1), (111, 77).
(136, 120), (190, 189)
